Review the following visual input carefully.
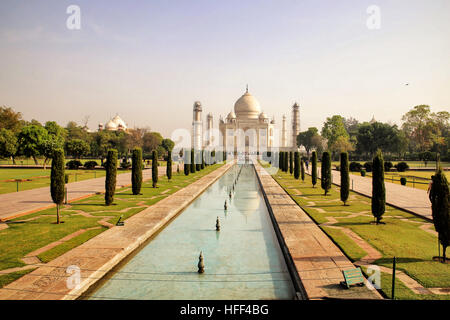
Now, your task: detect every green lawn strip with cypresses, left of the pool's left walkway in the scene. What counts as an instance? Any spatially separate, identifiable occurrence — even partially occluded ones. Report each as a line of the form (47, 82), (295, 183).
(0, 164), (221, 284)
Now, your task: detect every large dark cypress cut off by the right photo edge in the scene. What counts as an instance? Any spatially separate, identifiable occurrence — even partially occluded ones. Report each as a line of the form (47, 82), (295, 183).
(429, 163), (450, 263)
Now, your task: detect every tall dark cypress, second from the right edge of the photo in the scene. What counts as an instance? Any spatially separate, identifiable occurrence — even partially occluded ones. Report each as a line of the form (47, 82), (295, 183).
(372, 150), (386, 224)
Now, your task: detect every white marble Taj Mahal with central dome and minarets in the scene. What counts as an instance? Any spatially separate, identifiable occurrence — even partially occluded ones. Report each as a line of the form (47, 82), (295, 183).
(191, 86), (300, 154)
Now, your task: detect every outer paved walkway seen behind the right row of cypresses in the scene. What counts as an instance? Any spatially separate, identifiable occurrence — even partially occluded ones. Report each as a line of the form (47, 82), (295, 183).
(309, 166), (433, 220)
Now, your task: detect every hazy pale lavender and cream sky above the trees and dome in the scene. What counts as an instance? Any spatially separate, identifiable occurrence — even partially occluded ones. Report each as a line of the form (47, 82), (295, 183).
(0, 0), (450, 136)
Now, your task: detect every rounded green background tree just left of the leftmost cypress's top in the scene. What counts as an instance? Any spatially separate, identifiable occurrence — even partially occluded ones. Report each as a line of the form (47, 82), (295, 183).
(18, 125), (48, 165)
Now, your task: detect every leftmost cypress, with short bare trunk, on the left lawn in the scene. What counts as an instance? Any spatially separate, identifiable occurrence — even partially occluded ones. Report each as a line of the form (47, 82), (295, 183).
(50, 149), (65, 224)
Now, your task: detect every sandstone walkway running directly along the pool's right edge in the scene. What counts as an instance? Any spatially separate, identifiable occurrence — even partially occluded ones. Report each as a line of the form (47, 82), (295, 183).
(255, 162), (381, 299)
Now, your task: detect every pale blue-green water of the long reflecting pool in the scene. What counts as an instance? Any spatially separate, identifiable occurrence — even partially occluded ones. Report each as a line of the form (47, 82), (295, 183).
(89, 165), (294, 300)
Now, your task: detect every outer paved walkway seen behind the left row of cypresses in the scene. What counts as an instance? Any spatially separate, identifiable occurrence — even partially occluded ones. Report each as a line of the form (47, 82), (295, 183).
(0, 165), (177, 221)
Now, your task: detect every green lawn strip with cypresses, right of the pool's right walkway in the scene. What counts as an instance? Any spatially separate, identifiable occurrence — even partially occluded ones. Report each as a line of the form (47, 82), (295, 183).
(260, 162), (450, 299)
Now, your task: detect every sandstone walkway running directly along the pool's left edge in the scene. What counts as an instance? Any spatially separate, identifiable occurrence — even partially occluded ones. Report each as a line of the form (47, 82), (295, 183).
(0, 161), (235, 300)
